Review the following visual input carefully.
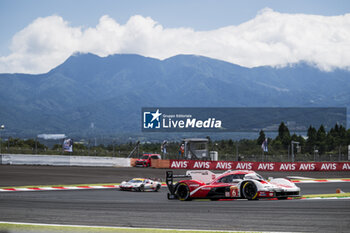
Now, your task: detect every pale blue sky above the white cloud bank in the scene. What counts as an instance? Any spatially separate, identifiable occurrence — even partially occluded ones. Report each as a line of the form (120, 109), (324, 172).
(0, 0), (350, 73)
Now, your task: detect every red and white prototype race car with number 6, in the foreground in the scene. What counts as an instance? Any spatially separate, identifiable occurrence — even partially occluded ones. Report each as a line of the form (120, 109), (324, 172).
(166, 170), (300, 201)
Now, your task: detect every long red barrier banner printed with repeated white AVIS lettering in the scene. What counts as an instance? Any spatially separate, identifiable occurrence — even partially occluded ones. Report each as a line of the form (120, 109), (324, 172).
(168, 160), (350, 171)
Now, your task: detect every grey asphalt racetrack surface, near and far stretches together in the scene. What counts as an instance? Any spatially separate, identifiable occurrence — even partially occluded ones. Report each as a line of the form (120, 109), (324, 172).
(0, 166), (350, 232)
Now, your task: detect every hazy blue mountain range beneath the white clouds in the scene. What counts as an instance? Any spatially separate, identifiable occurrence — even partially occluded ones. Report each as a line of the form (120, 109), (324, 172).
(0, 54), (350, 137)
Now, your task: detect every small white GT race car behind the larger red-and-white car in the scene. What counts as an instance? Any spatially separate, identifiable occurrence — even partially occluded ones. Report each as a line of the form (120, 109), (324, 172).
(119, 178), (162, 192)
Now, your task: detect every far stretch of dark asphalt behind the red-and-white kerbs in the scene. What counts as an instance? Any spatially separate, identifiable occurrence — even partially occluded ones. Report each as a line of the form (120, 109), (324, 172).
(0, 165), (350, 187)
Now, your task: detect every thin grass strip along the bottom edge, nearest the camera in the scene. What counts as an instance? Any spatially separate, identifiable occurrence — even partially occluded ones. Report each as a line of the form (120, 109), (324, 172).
(0, 222), (258, 233)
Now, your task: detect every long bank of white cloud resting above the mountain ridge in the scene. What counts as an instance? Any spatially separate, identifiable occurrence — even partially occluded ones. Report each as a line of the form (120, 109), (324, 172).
(0, 8), (350, 73)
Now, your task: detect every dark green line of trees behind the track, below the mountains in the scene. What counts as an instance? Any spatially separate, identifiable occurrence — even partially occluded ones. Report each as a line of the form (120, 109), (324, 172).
(1, 122), (350, 159)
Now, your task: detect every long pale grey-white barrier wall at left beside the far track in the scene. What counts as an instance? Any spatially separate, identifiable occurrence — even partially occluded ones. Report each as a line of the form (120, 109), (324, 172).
(0, 154), (131, 167)
